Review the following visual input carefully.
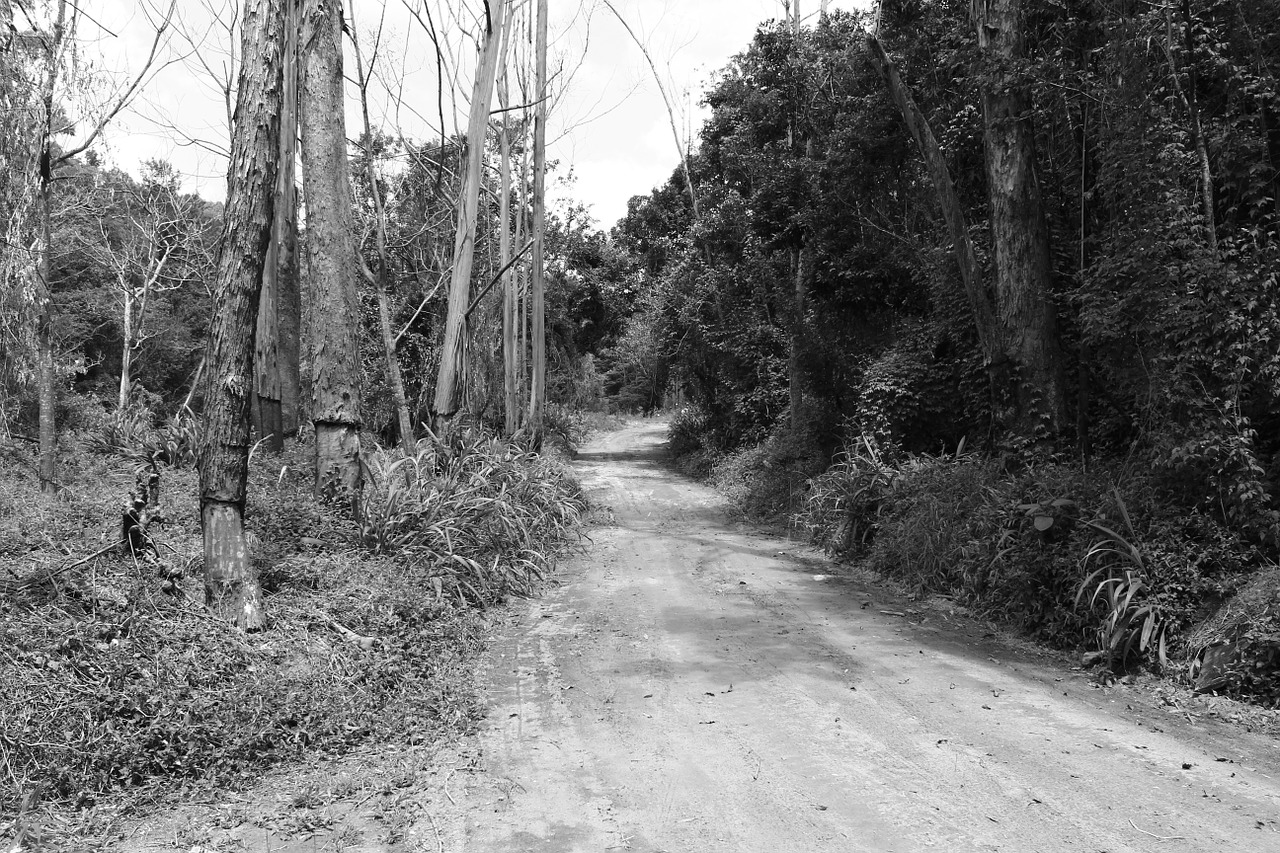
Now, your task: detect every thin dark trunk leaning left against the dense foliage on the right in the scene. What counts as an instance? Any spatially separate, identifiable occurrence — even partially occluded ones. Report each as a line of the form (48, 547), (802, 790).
(867, 35), (1006, 369)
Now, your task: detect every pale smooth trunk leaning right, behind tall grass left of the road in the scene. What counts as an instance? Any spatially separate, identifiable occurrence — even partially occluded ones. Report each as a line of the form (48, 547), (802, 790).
(431, 0), (507, 425)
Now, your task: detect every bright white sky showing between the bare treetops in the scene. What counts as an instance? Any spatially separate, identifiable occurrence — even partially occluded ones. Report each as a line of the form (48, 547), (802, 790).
(81, 0), (870, 228)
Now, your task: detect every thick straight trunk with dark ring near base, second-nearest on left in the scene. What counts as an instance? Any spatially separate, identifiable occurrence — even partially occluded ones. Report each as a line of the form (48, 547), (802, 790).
(301, 0), (361, 508)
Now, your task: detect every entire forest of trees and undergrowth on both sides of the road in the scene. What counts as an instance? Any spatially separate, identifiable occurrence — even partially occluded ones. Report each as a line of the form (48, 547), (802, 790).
(0, 0), (1280, 843)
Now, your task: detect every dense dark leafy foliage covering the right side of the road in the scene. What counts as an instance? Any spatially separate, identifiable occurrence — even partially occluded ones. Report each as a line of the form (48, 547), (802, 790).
(602, 0), (1280, 698)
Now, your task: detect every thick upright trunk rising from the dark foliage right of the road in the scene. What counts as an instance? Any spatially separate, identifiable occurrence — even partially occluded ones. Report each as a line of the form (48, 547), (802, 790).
(973, 0), (1066, 438)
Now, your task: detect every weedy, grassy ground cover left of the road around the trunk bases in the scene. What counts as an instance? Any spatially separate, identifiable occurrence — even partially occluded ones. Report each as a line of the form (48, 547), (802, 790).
(0, 422), (585, 839)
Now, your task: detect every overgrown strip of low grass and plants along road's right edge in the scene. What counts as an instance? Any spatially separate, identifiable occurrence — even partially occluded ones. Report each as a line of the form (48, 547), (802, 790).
(672, 421), (1280, 707)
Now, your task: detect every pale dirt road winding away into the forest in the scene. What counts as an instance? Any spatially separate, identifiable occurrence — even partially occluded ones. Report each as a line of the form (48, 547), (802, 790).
(420, 423), (1280, 853)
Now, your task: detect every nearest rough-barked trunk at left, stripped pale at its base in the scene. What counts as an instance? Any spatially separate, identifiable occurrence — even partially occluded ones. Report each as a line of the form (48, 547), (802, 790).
(200, 0), (284, 629)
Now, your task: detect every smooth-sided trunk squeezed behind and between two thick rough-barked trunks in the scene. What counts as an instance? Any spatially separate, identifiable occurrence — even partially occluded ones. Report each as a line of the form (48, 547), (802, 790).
(253, 0), (298, 453)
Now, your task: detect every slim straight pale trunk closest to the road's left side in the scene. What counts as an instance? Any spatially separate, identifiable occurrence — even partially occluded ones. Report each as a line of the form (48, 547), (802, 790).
(529, 0), (547, 438)
